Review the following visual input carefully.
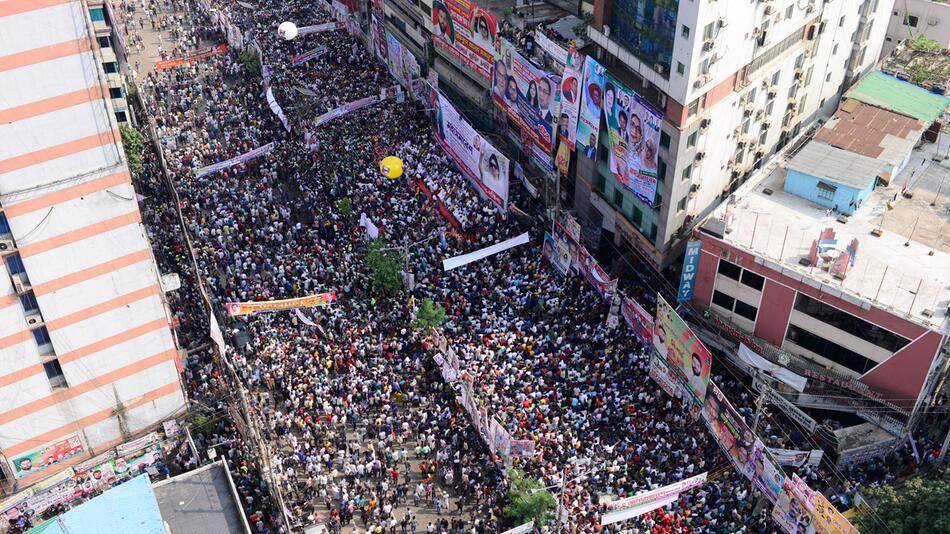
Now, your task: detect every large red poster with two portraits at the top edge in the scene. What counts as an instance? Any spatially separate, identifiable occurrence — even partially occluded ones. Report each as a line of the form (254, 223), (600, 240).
(427, 0), (498, 80)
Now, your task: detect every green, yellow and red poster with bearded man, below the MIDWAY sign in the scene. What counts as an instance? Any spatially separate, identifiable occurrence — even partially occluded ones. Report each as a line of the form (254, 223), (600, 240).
(653, 295), (712, 404)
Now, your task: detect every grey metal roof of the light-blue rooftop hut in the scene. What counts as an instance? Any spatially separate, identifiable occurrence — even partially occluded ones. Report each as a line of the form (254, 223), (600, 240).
(780, 140), (884, 189)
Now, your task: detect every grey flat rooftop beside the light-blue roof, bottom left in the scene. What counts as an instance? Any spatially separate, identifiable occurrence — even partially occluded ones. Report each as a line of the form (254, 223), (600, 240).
(154, 462), (248, 534)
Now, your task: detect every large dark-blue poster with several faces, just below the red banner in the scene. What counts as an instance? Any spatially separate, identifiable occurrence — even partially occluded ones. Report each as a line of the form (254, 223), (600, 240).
(492, 39), (559, 153)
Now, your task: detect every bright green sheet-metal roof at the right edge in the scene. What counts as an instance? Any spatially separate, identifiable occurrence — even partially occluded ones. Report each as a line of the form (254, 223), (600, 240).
(845, 71), (948, 124)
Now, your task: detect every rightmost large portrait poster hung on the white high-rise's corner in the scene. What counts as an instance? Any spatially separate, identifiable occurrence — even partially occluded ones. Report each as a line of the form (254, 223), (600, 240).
(603, 74), (663, 206)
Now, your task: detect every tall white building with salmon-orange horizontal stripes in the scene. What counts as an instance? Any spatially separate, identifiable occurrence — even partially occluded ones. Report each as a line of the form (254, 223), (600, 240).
(0, 0), (185, 489)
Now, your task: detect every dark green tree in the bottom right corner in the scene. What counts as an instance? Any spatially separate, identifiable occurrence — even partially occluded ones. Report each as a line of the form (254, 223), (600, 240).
(855, 478), (950, 534)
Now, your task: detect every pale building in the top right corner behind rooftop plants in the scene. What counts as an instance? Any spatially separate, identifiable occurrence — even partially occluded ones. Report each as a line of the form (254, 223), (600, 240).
(881, 0), (950, 56)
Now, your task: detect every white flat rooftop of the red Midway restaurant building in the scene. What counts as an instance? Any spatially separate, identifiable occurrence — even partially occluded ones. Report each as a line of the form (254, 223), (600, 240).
(704, 135), (950, 333)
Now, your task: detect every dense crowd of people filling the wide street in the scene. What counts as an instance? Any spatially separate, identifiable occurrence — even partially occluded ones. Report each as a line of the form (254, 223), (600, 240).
(106, 0), (950, 534)
